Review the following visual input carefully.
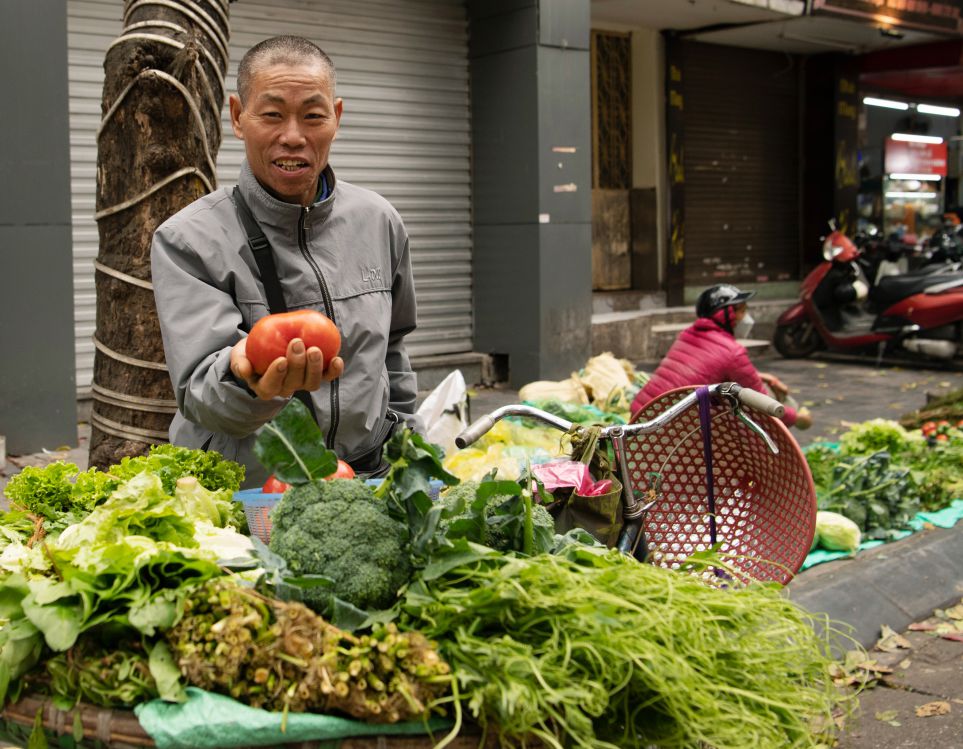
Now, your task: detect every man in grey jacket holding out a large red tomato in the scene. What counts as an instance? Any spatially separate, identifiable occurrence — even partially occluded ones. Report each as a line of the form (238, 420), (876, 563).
(151, 37), (420, 486)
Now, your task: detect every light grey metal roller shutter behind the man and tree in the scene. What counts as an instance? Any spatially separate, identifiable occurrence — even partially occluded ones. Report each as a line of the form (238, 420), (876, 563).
(67, 0), (472, 396)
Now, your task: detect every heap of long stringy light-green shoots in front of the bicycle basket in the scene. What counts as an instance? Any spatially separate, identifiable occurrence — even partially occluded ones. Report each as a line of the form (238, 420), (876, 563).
(402, 541), (842, 749)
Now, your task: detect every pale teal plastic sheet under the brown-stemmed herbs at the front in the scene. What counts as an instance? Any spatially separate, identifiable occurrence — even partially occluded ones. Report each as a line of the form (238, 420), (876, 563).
(134, 687), (451, 749)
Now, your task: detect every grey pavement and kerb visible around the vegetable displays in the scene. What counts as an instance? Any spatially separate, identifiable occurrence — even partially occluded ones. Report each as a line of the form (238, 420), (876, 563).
(0, 356), (963, 749)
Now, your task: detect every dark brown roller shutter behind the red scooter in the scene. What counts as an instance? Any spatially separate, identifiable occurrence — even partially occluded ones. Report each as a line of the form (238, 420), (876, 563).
(683, 42), (799, 286)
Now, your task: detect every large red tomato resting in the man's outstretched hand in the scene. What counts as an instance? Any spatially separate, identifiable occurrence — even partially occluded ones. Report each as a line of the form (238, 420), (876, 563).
(246, 309), (341, 374)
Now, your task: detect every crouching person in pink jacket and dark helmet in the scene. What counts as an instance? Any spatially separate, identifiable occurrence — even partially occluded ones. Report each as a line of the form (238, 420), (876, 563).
(632, 284), (812, 429)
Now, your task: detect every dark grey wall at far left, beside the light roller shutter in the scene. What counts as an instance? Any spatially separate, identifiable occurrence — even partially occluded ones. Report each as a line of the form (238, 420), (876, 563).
(0, 0), (77, 455)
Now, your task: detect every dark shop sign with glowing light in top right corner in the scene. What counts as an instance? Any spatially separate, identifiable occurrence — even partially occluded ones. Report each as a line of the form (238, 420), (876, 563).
(810, 0), (963, 34)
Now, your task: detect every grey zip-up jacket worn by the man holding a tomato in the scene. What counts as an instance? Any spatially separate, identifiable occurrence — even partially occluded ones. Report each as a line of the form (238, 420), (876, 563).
(151, 162), (418, 486)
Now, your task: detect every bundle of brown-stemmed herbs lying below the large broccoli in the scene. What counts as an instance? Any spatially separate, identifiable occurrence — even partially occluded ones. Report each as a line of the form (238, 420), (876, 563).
(167, 578), (451, 723)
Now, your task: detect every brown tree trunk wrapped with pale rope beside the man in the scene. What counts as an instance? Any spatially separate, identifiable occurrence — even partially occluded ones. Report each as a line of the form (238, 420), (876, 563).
(89, 0), (230, 469)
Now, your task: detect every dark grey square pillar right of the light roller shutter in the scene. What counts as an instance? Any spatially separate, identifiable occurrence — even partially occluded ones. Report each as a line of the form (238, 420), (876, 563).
(469, 0), (592, 387)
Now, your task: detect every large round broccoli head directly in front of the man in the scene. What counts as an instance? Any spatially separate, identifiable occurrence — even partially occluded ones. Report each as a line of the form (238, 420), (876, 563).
(269, 479), (413, 609)
